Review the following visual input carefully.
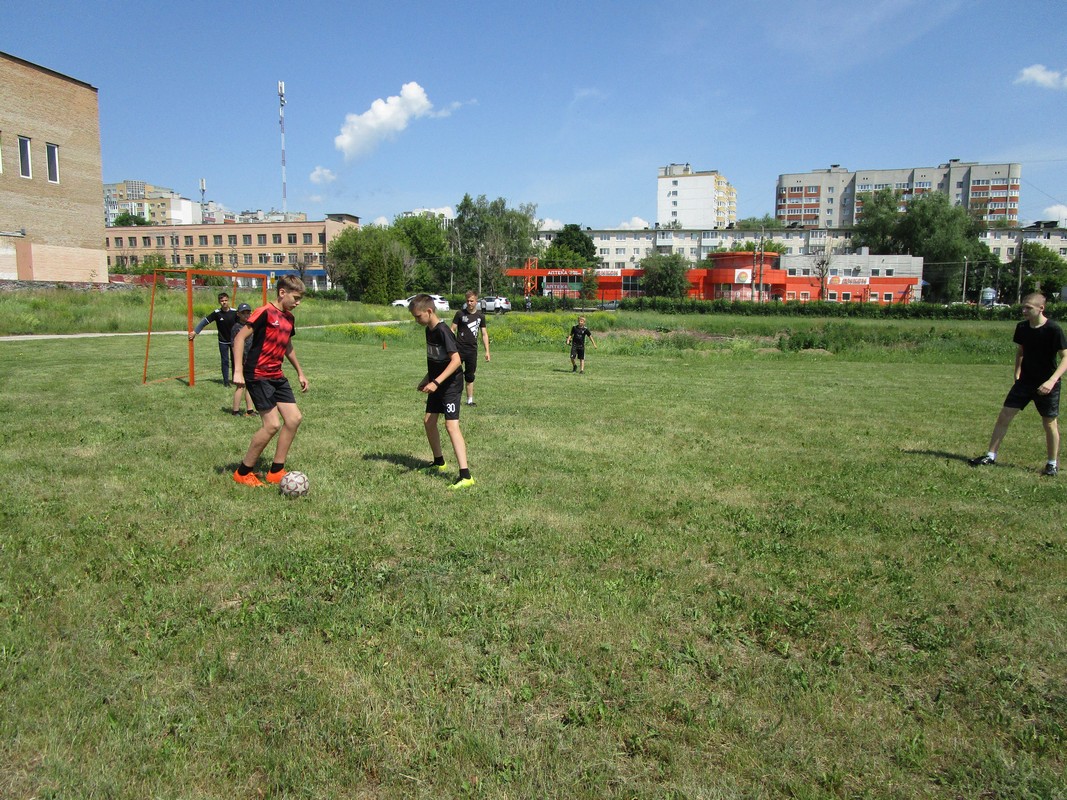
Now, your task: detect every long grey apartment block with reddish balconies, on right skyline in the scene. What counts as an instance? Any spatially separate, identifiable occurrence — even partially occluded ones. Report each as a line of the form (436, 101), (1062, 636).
(775, 159), (1022, 228)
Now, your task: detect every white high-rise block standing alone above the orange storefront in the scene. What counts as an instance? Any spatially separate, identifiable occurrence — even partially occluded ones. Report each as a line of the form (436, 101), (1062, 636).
(656, 164), (737, 228)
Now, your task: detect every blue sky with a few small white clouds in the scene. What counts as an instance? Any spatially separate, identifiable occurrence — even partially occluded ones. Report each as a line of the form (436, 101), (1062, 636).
(8, 0), (1067, 227)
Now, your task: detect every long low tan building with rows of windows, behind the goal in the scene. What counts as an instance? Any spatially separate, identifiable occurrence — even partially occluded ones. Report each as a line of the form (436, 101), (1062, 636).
(105, 213), (360, 289)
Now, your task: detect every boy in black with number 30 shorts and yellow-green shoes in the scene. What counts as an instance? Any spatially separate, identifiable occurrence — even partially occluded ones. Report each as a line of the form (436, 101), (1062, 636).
(408, 294), (474, 490)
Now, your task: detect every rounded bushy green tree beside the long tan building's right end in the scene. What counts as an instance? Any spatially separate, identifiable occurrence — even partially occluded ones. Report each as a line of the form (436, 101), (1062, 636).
(328, 225), (410, 305)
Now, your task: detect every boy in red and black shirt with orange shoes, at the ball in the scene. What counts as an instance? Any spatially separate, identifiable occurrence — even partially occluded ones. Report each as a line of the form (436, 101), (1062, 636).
(234, 275), (307, 486)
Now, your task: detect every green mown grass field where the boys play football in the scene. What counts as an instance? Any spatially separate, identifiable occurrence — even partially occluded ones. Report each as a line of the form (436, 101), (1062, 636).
(0, 307), (1067, 799)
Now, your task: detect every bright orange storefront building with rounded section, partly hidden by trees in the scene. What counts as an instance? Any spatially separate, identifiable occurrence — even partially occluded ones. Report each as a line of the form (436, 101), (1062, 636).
(506, 251), (921, 304)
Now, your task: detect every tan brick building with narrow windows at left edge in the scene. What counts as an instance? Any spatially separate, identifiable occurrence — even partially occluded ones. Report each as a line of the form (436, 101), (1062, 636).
(0, 52), (108, 283)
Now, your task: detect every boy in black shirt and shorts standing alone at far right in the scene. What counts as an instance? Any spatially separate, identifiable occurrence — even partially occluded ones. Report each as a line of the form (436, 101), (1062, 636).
(970, 293), (1067, 478)
